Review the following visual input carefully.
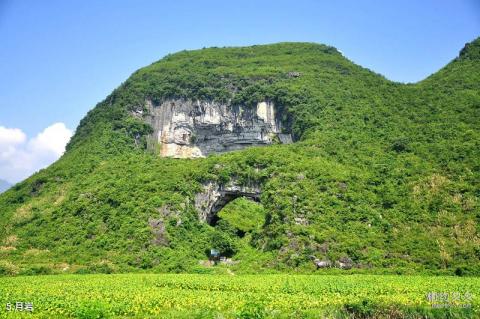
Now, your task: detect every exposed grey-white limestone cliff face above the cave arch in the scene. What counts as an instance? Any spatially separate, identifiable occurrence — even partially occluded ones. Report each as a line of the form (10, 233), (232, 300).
(144, 99), (292, 158)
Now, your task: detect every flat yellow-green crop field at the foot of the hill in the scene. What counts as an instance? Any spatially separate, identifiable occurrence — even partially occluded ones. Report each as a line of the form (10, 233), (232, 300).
(0, 274), (480, 318)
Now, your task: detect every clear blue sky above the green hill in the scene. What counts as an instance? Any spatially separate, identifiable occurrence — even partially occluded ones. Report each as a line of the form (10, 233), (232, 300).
(0, 0), (480, 184)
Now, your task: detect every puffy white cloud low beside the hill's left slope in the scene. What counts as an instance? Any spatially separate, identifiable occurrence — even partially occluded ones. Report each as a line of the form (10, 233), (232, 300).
(0, 123), (72, 183)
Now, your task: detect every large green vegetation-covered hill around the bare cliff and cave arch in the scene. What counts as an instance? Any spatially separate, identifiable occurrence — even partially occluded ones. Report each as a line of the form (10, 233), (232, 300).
(0, 39), (480, 275)
